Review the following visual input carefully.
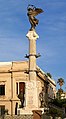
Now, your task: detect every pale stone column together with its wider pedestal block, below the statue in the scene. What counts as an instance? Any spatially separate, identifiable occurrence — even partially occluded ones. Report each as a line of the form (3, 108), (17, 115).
(26, 30), (39, 108)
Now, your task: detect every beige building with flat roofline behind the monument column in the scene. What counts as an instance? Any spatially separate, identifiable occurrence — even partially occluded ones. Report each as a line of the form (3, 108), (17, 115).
(0, 61), (56, 115)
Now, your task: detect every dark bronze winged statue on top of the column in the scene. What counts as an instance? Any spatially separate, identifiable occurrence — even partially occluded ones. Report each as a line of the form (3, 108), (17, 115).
(27, 5), (43, 30)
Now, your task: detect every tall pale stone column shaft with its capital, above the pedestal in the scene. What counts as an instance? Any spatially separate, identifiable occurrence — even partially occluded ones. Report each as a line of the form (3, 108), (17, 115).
(26, 30), (39, 80)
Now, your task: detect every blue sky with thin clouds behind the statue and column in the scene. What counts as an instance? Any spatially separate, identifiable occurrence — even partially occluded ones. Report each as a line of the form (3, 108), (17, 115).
(0, 0), (66, 90)
